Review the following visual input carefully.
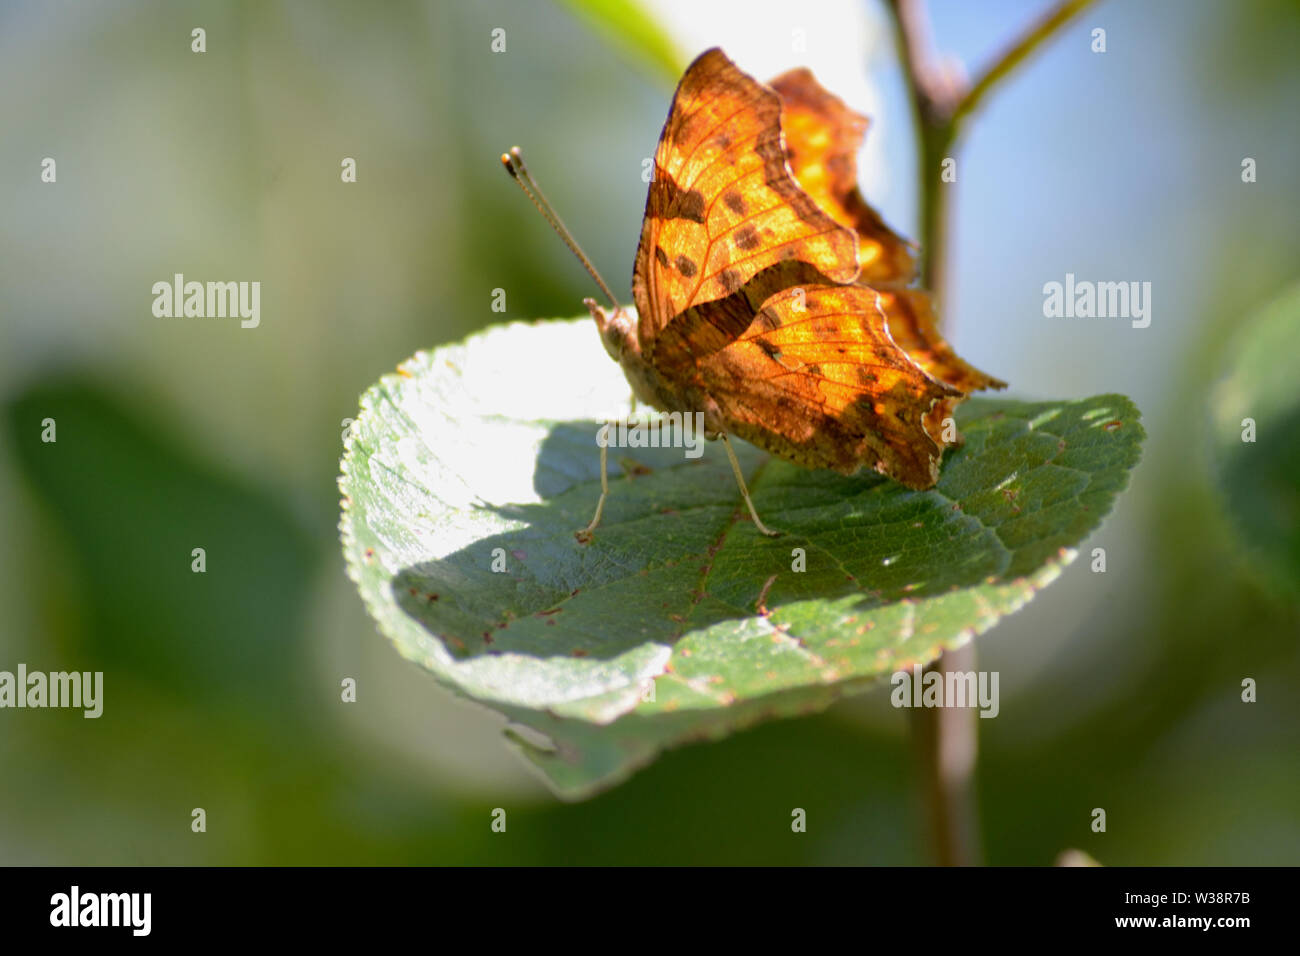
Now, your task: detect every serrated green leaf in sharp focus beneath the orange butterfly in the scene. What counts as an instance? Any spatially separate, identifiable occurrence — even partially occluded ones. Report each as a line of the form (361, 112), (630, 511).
(339, 319), (1143, 796)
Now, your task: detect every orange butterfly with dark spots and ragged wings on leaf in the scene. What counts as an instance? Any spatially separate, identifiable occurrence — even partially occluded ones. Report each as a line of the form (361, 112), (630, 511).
(502, 48), (1005, 540)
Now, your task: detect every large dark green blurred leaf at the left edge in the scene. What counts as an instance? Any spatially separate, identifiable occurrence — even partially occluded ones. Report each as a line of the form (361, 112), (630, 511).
(4, 380), (316, 713)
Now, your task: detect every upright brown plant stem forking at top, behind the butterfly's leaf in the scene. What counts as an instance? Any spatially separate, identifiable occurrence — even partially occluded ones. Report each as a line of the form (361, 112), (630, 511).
(888, 0), (1092, 866)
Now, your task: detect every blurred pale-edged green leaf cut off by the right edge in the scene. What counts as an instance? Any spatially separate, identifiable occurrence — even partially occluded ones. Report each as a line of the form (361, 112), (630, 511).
(1210, 285), (1300, 591)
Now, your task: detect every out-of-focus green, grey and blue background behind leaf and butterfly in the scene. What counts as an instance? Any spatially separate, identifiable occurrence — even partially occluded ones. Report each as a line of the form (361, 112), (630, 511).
(0, 0), (1300, 865)
